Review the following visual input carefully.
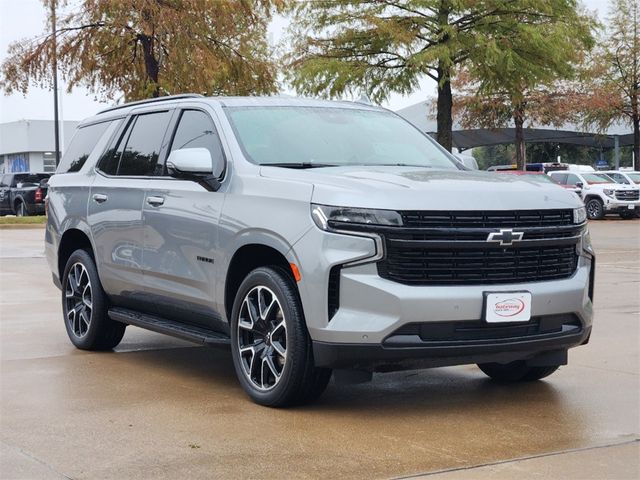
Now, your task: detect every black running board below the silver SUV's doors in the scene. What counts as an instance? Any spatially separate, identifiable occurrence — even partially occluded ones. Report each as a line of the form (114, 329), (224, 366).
(109, 307), (231, 346)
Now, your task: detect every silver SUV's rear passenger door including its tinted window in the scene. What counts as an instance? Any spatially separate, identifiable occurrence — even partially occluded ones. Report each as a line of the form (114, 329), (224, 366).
(88, 109), (173, 308)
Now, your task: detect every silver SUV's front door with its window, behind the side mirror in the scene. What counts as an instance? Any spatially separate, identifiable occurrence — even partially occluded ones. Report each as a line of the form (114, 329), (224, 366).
(142, 107), (226, 330)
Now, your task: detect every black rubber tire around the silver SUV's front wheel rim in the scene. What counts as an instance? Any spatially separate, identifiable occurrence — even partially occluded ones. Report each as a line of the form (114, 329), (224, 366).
(231, 267), (308, 406)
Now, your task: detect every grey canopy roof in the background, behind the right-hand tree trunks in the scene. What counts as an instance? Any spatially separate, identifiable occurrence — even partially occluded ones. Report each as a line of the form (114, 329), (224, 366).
(396, 101), (633, 149)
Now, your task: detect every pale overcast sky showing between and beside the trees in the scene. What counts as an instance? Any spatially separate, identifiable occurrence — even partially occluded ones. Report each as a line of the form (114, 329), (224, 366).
(0, 0), (609, 123)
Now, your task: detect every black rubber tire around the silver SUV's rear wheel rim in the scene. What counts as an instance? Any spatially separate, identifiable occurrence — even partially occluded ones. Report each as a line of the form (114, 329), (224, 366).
(62, 250), (109, 350)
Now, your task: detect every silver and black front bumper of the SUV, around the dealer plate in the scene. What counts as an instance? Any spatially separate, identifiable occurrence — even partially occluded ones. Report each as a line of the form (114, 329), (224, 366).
(291, 229), (593, 369)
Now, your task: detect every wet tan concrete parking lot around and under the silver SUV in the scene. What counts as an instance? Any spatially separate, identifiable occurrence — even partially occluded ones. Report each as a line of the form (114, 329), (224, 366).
(0, 218), (640, 479)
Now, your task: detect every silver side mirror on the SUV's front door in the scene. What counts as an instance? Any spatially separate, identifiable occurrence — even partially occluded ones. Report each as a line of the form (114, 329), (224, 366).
(167, 148), (220, 192)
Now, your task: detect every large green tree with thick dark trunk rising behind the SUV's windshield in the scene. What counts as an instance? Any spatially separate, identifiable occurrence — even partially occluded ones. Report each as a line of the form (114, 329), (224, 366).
(286, 0), (596, 149)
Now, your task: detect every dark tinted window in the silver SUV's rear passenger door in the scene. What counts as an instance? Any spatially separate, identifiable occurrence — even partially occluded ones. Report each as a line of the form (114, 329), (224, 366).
(118, 112), (171, 176)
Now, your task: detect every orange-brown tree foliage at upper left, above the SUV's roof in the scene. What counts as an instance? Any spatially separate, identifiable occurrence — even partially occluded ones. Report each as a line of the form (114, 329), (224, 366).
(0, 0), (284, 100)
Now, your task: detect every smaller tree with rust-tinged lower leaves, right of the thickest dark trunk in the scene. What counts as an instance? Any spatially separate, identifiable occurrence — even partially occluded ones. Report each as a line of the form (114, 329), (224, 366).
(450, 1), (596, 169)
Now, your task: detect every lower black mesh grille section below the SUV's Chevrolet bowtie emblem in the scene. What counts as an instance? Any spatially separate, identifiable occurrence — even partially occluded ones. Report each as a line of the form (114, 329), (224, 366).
(378, 245), (578, 285)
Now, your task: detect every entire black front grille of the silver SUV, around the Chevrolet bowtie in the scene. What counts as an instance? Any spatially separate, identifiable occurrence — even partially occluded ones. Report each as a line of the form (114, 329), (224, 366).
(377, 209), (584, 285)
